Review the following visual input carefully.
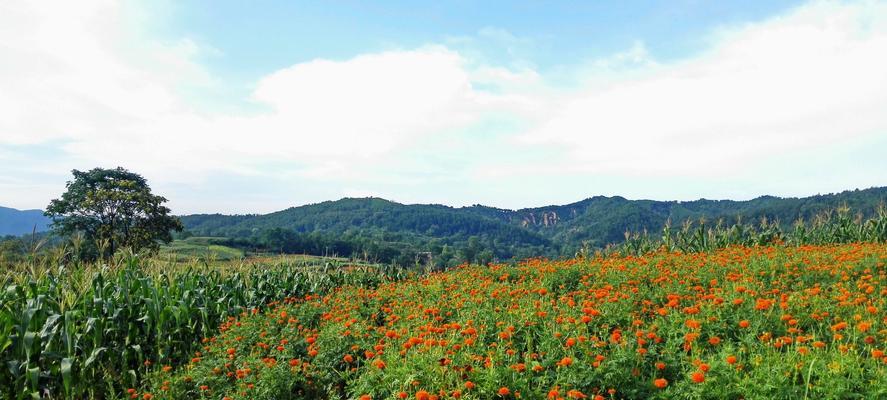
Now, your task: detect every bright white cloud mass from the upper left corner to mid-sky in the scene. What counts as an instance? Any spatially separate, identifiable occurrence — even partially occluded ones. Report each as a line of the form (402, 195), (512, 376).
(0, 0), (518, 189)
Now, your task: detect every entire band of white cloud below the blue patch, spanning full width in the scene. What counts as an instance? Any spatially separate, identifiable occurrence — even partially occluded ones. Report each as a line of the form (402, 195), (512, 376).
(0, 0), (887, 211)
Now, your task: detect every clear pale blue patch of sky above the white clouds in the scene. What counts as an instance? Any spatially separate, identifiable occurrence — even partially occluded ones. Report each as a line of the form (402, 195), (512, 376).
(154, 1), (800, 70)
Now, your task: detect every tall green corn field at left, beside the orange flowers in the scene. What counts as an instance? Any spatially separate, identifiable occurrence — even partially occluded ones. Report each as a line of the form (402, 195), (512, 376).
(0, 254), (396, 399)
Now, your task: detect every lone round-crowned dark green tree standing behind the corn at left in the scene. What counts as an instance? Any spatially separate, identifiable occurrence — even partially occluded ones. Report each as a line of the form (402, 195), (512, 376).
(45, 167), (182, 257)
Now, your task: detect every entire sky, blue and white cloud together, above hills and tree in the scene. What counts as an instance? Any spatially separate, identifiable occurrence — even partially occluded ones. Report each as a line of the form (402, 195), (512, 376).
(0, 0), (887, 214)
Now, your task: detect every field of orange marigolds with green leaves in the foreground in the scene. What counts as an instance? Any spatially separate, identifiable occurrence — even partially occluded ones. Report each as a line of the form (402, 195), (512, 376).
(144, 244), (887, 399)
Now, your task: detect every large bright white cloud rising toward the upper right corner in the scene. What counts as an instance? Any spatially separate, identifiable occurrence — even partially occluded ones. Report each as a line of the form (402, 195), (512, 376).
(522, 3), (887, 176)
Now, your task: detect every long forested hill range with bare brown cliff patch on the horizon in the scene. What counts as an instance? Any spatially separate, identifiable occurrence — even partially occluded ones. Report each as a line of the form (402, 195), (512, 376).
(182, 187), (887, 266)
